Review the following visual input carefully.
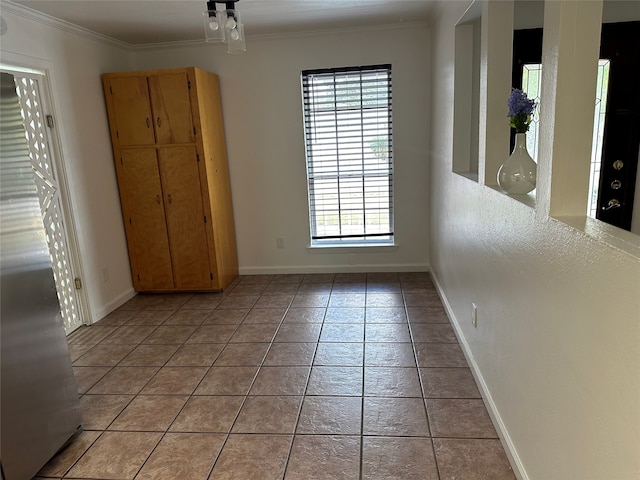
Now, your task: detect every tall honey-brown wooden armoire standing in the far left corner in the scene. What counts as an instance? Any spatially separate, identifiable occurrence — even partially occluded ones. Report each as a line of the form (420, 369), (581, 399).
(102, 67), (238, 292)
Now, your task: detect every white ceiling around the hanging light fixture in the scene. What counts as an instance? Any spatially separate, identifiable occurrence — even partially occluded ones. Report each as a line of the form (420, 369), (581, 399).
(13, 0), (436, 45)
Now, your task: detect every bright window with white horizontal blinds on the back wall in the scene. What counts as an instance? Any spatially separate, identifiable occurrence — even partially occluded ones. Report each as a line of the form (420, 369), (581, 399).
(302, 65), (393, 246)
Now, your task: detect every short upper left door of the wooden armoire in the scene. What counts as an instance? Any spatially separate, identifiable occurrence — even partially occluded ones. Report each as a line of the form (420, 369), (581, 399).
(105, 76), (155, 146)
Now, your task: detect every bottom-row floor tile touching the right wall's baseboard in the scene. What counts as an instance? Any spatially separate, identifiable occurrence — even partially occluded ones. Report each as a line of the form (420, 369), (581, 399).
(433, 438), (516, 480)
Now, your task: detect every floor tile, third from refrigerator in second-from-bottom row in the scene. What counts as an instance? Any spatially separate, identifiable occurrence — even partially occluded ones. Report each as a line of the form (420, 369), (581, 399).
(169, 396), (244, 433)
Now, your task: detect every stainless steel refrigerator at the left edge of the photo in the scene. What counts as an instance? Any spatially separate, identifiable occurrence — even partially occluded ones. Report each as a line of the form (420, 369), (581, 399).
(0, 73), (82, 480)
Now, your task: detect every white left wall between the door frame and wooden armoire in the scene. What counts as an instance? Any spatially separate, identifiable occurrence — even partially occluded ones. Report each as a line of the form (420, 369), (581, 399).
(0, 5), (133, 321)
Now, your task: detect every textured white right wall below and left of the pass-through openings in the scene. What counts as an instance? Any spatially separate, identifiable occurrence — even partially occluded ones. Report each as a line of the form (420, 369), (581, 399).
(429, 1), (640, 480)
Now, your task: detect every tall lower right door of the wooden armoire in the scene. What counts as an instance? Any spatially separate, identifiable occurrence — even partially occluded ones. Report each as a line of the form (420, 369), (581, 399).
(158, 147), (211, 289)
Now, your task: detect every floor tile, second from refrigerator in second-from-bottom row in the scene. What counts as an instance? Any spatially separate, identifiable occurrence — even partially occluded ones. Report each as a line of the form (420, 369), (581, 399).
(109, 395), (189, 432)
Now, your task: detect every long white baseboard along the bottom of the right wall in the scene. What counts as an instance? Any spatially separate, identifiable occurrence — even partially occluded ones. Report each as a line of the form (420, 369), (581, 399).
(431, 271), (529, 480)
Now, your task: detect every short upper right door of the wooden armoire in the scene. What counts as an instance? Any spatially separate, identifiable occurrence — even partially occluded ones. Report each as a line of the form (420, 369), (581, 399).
(149, 73), (195, 145)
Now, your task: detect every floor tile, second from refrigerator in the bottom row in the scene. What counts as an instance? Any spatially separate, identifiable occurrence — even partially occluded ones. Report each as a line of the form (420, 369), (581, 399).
(68, 432), (162, 480)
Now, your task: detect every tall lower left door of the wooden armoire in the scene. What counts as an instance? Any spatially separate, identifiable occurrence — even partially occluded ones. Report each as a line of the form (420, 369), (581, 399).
(122, 148), (174, 290)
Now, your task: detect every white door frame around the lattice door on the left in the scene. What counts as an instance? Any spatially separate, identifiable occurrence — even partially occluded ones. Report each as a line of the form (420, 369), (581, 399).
(0, 51), (93, 335)
